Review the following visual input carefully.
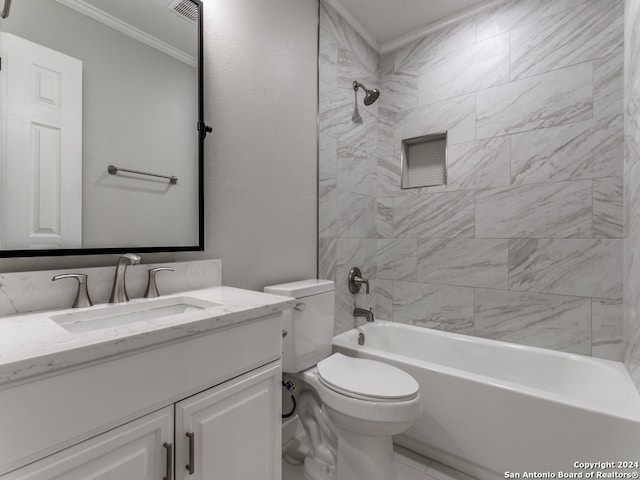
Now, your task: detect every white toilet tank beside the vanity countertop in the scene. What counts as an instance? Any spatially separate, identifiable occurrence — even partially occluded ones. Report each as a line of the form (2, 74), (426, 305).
(264, 280), (335, 373)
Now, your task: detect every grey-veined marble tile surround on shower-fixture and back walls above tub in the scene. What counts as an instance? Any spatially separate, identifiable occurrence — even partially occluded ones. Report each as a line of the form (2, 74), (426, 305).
(319, 0), (624, 360)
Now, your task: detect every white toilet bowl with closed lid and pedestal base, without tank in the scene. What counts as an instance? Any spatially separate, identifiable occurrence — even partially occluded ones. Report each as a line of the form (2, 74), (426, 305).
(294, 353), (422, 480)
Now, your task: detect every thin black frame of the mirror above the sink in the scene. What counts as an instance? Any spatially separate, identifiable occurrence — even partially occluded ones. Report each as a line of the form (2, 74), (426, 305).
(0, 0), (212, 258)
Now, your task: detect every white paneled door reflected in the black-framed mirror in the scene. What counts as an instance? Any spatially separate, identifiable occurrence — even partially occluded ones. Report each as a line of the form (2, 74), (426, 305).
(0, 32), (82, 249)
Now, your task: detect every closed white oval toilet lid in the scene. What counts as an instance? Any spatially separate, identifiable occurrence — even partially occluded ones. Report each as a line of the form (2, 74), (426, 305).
(318, 353), (419, 401)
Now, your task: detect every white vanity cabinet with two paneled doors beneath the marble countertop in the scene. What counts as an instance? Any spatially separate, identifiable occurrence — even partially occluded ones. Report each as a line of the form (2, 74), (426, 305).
(0, 311), (282, 480)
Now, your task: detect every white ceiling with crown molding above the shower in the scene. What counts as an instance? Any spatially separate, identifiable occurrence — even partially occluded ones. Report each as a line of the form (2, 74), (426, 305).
(327, 0), (507, 52)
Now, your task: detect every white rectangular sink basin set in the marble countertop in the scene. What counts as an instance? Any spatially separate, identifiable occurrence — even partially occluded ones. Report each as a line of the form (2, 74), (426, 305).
(51, 297), (220, 333)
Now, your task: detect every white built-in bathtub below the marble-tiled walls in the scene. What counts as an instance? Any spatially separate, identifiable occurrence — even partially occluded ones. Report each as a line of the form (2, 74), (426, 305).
(333, 320), (640, 479)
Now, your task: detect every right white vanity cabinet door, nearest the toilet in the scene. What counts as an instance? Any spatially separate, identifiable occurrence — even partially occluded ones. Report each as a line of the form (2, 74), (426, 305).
(176, 361), (282, 480)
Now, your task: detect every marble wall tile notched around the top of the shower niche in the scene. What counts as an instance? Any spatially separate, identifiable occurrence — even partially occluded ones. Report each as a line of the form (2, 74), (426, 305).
(394, 94), (476, 147)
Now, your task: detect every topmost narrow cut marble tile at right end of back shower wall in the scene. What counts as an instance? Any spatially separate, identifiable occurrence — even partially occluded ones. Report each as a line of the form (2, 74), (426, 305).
(593, 45), (624, 119)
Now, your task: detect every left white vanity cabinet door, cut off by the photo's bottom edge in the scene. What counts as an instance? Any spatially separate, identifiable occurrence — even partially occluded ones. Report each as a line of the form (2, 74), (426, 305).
(2, 406), (173, 480)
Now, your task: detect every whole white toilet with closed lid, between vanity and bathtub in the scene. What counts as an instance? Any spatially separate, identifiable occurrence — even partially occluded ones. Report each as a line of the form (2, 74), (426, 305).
(264, 280), (422, 480)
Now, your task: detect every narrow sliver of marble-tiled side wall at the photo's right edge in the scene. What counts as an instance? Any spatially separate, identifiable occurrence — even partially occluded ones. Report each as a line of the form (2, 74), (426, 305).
(624, 0), (640, 391)
